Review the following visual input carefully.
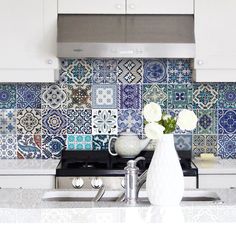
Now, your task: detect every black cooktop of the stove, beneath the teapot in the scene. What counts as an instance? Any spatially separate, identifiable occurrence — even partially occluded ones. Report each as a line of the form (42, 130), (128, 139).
(56, 150), (198, 176)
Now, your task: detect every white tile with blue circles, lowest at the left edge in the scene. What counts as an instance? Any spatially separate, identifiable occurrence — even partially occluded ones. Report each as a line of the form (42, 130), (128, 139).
(0, 135), (16, 159)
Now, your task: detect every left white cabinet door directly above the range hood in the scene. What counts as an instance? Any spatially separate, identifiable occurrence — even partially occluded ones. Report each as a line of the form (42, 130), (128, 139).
(58, 0), (125, 14)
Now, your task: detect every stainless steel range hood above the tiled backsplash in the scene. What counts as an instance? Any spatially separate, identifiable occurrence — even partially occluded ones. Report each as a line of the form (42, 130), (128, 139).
(58, 15), (195, 58)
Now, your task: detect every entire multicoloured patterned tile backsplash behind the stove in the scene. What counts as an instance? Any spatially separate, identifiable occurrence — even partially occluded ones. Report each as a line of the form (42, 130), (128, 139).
(0, 59), (236, 159)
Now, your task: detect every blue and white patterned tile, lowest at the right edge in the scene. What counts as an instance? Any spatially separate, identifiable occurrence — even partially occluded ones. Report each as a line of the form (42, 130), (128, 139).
(218, 134), (236, 158)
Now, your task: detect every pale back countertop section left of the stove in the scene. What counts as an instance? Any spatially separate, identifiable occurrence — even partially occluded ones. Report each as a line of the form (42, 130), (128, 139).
(0, 159), (59, 175)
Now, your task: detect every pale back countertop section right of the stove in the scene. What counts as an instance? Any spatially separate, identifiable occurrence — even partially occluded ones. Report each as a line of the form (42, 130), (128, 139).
(193, 158), (236, 175)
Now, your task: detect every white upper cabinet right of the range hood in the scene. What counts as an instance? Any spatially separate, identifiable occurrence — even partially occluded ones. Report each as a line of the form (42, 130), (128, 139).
(195, 0), (236, 82)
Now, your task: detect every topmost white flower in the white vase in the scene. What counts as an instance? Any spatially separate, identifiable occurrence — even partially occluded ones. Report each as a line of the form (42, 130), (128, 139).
(143, 102), (162, 122)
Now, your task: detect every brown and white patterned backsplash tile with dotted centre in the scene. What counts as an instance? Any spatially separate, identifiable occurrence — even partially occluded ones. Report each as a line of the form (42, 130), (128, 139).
(68, 84), (92, 109)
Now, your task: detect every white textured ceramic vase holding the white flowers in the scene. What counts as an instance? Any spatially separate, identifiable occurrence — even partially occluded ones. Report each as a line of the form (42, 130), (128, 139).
(146, 134), (184, 206)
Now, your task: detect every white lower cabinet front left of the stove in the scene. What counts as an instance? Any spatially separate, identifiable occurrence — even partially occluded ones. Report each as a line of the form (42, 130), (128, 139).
(0, 175), (55, 189)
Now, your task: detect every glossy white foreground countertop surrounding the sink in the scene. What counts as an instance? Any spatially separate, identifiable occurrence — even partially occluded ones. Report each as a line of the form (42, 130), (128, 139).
(0, 189), (236, 224)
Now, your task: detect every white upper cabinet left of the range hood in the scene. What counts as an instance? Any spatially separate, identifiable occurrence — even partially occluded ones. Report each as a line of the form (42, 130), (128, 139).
(0, 0), (58, 82)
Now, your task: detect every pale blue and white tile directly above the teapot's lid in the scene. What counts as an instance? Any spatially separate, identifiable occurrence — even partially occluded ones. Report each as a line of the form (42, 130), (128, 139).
(118, 110), (143, 134)
